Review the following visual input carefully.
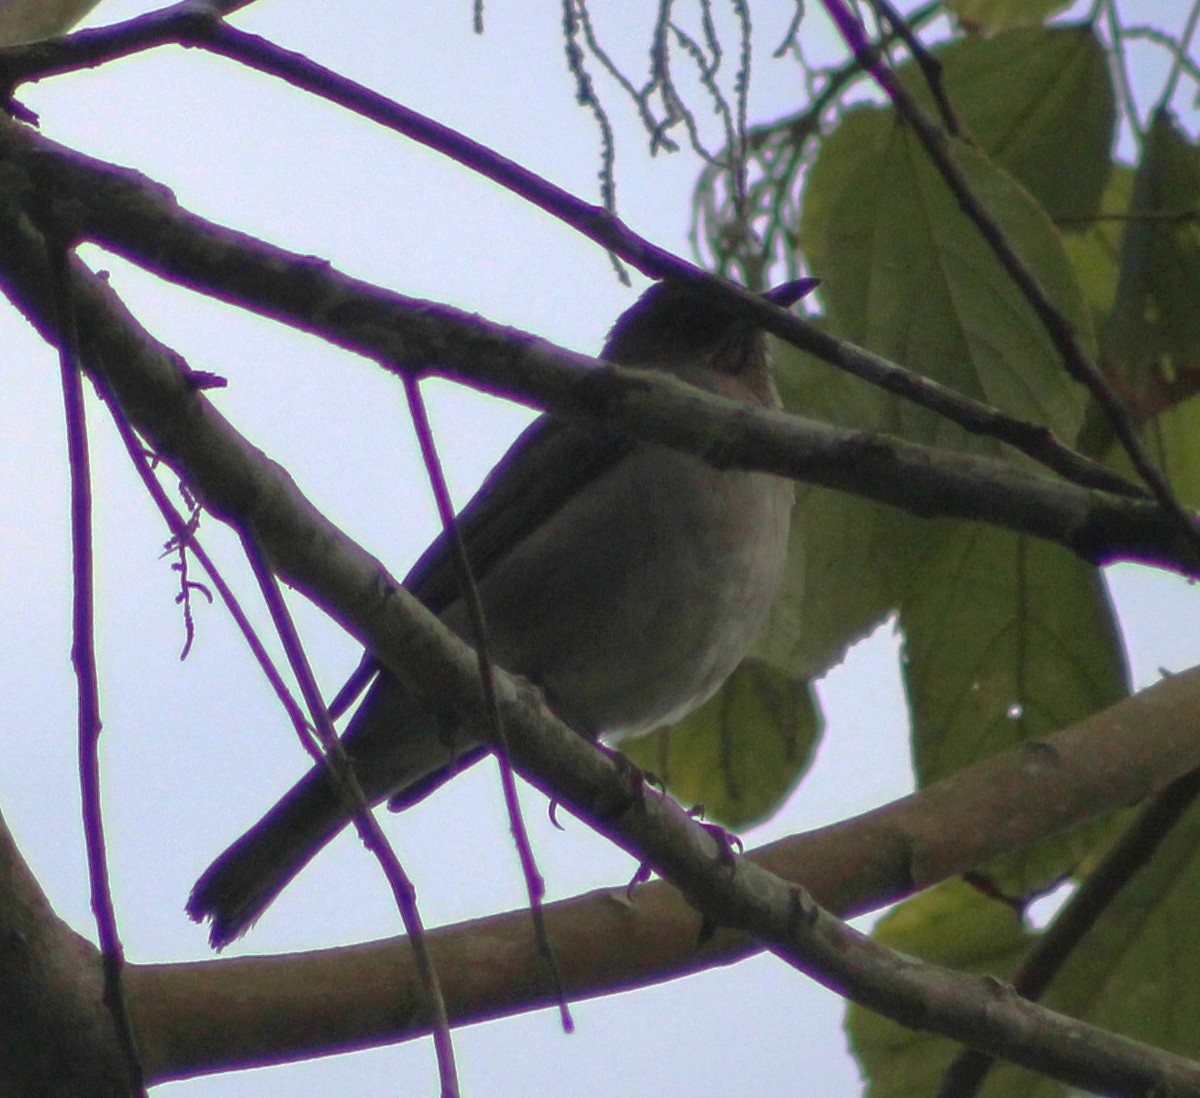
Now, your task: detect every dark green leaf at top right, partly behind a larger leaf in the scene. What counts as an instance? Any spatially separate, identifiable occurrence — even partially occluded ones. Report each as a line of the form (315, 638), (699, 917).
(896, 24), (1116, 218)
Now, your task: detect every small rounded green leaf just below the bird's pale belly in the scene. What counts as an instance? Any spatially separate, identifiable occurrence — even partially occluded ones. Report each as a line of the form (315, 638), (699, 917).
(620, 656), (822, 828)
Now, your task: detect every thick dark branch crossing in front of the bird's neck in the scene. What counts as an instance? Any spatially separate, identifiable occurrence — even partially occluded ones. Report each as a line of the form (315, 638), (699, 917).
(0, 126), (1185, 572)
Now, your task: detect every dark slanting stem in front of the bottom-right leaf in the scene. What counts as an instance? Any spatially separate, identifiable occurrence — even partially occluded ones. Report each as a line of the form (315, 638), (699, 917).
(936, 770), (1200, 1098)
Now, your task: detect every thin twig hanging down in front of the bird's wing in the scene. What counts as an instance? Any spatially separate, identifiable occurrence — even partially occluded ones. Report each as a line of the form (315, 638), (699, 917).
(404, 373), (575, 1033)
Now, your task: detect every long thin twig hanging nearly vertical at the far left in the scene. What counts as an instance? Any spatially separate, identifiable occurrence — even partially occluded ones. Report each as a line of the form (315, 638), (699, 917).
(47, 238), (145, 1098)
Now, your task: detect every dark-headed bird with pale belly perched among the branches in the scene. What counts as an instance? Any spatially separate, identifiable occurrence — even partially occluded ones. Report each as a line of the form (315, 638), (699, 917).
(187, 280), (815, 949)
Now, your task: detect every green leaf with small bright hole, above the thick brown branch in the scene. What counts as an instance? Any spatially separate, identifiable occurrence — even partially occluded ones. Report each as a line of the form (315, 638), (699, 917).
(900, 522), (1129, 895)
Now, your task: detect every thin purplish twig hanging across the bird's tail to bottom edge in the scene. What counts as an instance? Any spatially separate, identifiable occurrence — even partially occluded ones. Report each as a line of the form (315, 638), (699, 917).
(240, 528), (458, 1098)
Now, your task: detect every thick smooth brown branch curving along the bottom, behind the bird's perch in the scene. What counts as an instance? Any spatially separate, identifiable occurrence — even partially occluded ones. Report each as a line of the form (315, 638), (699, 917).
(121, 671), (1200, 1080)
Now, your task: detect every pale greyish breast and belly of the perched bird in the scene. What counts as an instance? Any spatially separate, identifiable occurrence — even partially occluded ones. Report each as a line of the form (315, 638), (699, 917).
(460, 444), (793, 738)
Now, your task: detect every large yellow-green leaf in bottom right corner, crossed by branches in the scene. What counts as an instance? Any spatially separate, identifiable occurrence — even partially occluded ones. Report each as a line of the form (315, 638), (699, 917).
(847, 805), (1200, 1098)
